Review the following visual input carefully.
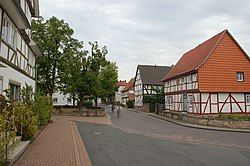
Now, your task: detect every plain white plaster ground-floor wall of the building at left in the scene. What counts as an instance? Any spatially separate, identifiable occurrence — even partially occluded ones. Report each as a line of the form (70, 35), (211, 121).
(0, 62), (35, 92)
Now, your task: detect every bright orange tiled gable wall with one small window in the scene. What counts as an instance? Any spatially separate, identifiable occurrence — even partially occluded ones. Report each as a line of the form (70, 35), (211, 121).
(198, 32), (250, 92)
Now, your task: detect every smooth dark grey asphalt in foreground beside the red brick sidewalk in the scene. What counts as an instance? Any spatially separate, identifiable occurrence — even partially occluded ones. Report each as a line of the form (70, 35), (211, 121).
(77, 122), (250, 166)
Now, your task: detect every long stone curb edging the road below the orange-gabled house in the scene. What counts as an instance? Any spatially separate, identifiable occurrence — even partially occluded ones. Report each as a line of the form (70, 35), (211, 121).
(128, 109), (250, 133)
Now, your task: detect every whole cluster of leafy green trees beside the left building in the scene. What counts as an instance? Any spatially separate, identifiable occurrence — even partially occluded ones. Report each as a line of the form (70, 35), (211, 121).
(32, 17), (118, 108)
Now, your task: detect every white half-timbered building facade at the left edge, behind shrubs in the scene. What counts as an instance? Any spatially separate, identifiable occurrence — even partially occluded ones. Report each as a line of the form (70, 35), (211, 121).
(0, 0), (42, 100)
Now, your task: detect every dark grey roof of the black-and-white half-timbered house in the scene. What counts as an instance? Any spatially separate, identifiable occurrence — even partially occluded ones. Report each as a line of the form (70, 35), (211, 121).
(137, 65), (171, 85)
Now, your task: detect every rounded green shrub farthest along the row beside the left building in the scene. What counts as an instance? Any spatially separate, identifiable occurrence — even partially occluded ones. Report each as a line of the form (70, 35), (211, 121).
(32, 94), (53, 126)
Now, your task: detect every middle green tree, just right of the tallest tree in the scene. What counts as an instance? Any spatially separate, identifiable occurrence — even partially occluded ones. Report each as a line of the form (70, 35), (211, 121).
(57, 40), (89, 110)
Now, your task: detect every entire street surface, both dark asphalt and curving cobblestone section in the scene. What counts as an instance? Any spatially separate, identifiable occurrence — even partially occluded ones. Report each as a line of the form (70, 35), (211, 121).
(77, 107), (250, 166)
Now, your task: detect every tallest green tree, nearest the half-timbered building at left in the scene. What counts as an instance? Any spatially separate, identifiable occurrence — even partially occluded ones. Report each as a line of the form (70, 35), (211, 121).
(31, 17), (77, 96)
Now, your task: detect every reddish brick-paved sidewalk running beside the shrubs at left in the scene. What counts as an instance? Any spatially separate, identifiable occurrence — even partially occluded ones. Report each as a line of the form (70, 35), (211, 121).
(14, 116), (91, 166)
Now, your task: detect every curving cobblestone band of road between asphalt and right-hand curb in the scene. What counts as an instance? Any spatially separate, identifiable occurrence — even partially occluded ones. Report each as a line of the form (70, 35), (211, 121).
(106, 107), (250, 150)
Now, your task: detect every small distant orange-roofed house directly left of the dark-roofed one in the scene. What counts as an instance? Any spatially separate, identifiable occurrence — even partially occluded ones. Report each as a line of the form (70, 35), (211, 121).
(122, 78), (135, 105)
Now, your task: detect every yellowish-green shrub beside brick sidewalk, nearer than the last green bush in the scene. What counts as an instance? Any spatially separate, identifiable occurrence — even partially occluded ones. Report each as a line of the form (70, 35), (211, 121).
(13, 102), (38, 140)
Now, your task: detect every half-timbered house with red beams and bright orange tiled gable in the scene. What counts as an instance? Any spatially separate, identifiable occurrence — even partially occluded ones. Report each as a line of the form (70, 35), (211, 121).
(163, 30), (250, 114)
